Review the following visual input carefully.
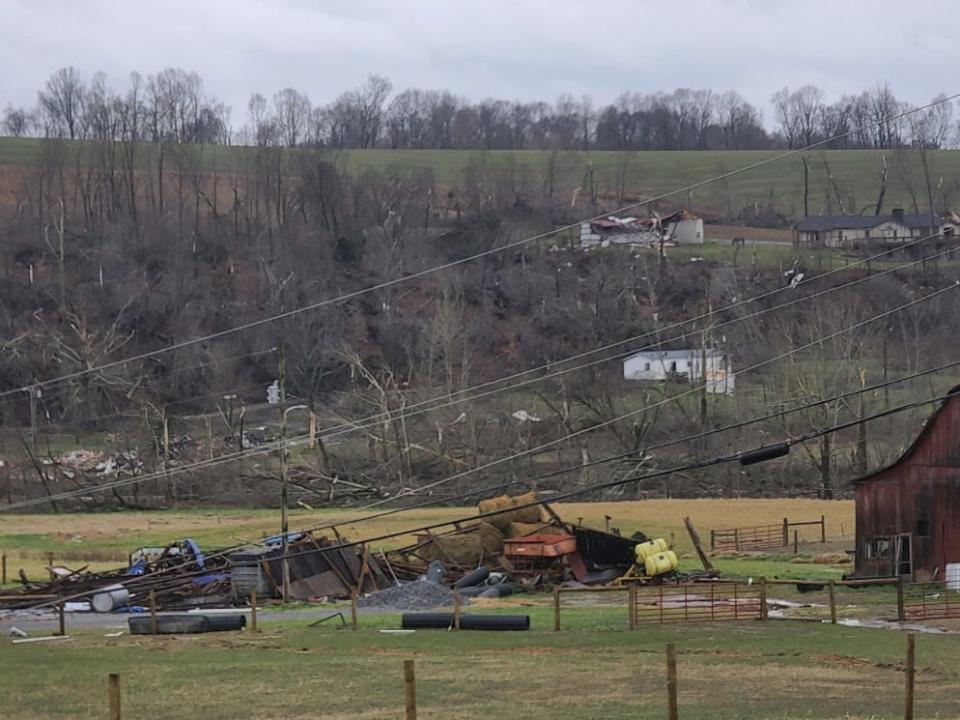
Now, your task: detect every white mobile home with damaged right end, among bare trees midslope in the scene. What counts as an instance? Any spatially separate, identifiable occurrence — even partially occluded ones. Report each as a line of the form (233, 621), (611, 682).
(623, 348), (735, 395)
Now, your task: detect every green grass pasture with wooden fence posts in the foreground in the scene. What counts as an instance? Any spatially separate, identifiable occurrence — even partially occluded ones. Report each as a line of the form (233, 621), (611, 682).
(0, 606), (960, 720)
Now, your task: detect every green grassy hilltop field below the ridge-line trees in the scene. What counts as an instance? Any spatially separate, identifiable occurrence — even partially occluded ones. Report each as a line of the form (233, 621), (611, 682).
(0, 138), (960, 218)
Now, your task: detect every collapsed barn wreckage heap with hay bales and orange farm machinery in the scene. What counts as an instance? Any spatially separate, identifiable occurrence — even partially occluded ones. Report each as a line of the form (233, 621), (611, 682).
(0, 492), (660, 611)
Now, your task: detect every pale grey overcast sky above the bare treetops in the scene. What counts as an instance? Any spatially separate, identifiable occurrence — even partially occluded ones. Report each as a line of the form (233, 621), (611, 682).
(0, 0), (960, 126)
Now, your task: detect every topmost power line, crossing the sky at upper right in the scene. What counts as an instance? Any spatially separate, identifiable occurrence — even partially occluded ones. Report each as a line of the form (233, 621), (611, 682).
(0, 93), (960, 397)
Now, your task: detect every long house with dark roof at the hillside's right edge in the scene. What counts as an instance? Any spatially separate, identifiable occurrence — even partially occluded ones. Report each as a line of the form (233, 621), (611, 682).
(794, 208), (958, 248)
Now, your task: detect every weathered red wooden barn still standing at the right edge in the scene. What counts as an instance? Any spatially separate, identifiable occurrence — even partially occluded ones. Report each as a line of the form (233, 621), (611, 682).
(854, 386), (960, 581)
